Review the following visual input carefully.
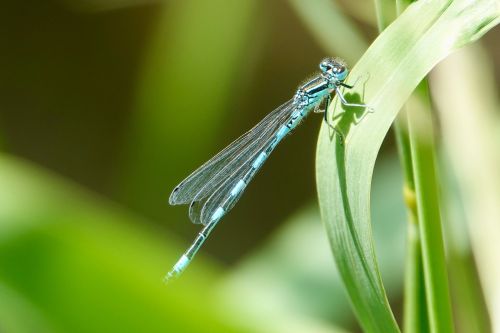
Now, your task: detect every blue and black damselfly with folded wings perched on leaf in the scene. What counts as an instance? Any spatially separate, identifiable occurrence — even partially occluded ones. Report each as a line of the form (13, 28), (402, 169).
(166, 58), (367, 280)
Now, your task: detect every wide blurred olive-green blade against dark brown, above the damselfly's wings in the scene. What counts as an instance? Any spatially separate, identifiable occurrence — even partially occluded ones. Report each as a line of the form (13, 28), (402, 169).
(117, 0), (256, 217)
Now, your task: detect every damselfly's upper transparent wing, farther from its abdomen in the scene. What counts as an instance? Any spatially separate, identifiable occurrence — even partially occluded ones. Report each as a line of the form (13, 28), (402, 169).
(169, 100), (293, 206)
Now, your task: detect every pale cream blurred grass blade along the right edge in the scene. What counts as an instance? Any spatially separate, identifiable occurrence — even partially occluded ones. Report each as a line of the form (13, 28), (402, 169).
(432, 45), (500, 332)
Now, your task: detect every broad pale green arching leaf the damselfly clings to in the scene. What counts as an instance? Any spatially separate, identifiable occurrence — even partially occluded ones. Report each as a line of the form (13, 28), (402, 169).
(317, 0), (499, 333)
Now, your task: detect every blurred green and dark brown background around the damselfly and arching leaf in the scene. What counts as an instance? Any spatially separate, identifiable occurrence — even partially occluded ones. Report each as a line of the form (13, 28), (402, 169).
(0, 0), (500, 332)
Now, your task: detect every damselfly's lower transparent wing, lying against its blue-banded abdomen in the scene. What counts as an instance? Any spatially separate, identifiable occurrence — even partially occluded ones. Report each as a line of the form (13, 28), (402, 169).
(189, 108), (302, 225)
